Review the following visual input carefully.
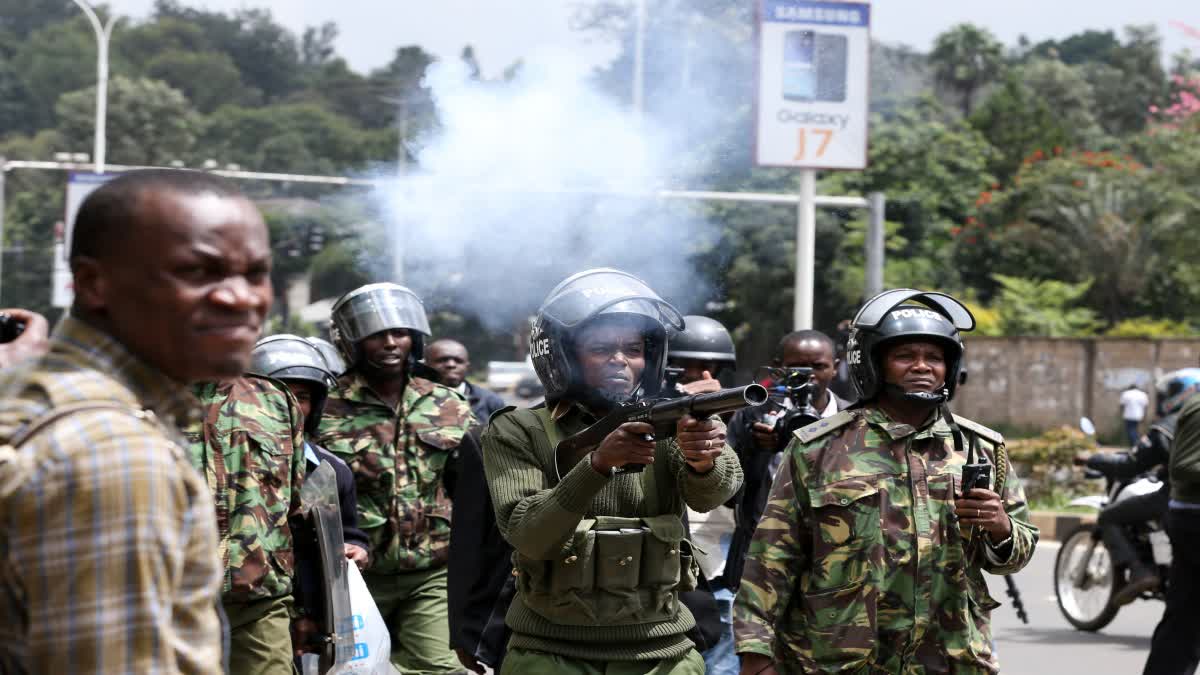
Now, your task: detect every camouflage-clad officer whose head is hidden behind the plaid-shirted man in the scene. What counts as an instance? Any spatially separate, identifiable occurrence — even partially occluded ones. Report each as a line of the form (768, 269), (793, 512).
(185, 375), (305, 675)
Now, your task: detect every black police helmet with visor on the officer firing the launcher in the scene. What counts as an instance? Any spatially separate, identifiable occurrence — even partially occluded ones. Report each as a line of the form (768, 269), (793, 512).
(529, 268), (684, 402)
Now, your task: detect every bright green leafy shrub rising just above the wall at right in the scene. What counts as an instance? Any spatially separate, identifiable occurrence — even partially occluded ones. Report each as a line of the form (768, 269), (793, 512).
(992, 274), (1098, 338)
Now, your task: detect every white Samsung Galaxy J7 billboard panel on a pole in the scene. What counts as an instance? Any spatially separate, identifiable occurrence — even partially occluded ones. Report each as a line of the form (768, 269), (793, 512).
(755, 0), (871, 169)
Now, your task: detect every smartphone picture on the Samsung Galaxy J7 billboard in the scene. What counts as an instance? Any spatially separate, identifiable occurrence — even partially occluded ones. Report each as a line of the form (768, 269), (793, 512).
(784, 30), (847, 102)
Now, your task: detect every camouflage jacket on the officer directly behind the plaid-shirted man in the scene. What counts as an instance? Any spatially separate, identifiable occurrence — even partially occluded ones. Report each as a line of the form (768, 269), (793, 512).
(185, 376), (305, 604)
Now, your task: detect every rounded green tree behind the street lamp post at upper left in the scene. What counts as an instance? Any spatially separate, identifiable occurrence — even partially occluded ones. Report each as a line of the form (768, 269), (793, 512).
(55, 77), (199, 165)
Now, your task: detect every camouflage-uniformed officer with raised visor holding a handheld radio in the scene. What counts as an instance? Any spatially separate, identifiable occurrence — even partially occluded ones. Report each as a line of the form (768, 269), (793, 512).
(734, 289), (1038, 675)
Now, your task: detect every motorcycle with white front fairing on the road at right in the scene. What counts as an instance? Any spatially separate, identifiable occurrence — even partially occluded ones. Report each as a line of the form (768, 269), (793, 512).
(1054, 418), (1171, 632)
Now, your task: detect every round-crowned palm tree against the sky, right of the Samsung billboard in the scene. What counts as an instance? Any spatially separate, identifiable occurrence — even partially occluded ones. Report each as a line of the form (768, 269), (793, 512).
(929, 24), (1004, 117)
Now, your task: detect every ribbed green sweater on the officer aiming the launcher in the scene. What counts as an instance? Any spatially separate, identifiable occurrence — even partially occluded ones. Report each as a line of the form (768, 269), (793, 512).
(484, 398), (742, 661)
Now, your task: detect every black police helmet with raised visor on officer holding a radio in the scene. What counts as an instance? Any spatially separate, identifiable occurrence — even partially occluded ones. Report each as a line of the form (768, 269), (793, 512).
(846, 288), (974, 405)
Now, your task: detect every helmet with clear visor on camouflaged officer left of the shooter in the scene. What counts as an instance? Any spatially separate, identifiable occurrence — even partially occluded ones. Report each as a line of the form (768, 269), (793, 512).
(330, 282), (432, 368)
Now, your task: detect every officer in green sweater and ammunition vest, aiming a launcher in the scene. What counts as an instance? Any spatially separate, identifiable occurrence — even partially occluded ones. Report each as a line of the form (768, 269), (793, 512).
(484, 269), (742, 675)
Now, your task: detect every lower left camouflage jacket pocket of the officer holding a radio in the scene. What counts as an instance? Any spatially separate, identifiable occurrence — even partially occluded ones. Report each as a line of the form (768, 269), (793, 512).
(804, 583), (878, 673)
